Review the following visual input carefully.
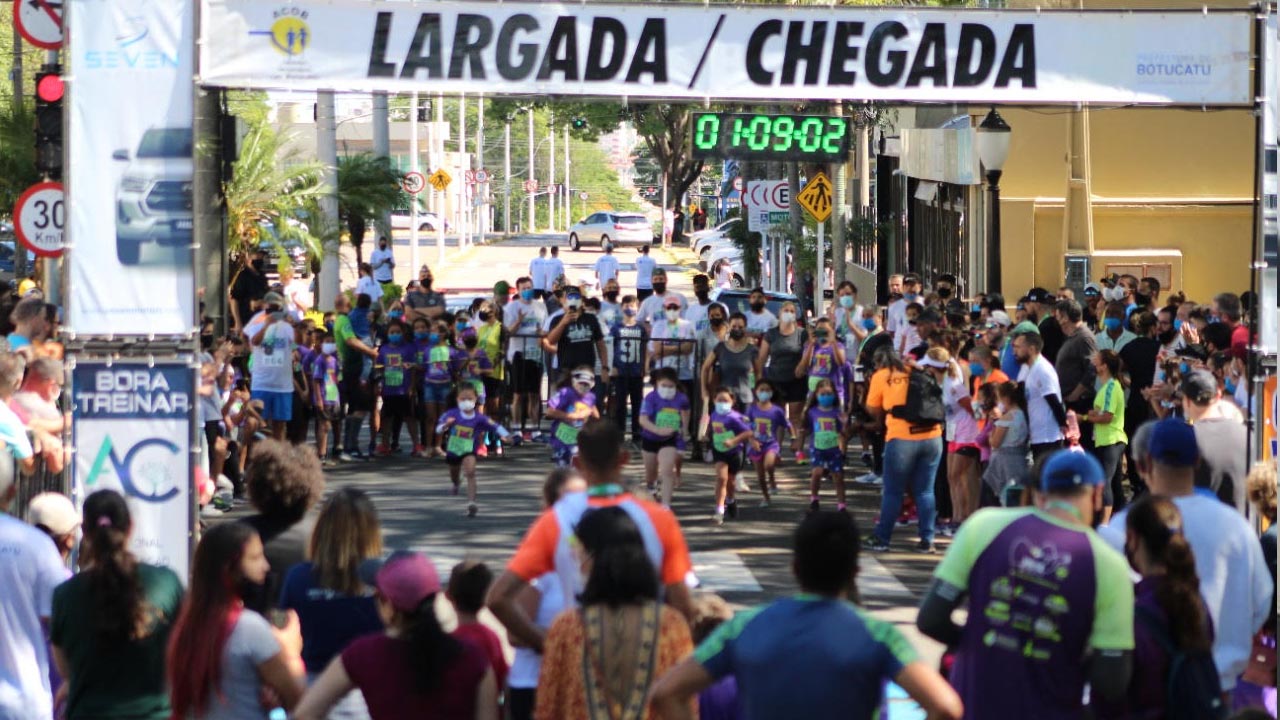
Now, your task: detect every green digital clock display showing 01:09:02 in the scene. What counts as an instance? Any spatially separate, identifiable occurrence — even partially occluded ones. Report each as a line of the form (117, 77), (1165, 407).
(692, 113), (850, 163)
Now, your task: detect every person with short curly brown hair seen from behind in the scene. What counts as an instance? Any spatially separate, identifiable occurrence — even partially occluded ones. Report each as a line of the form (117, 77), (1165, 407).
(242, 439), (324, 612)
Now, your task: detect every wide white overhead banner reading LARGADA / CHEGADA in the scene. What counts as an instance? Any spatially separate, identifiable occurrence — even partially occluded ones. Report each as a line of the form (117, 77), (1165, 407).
(200, 0), (1253, 106)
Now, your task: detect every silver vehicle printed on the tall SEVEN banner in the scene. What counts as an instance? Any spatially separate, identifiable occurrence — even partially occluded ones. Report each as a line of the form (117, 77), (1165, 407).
(111, 127), (193, 265)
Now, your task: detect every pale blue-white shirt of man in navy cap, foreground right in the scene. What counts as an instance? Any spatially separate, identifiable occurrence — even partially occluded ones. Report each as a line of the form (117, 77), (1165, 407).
(1098, 495), (1275, 691)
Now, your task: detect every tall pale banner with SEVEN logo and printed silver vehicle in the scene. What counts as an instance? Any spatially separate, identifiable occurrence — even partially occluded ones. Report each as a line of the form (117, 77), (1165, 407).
(64, 0), (196, 336)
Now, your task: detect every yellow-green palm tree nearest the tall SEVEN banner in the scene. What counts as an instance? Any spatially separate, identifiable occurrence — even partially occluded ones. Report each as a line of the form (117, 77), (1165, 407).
(223, 123), (324, 263)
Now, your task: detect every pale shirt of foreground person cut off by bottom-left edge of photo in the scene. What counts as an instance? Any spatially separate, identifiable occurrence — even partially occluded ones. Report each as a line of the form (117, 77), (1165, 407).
(0, 512), (70, 720)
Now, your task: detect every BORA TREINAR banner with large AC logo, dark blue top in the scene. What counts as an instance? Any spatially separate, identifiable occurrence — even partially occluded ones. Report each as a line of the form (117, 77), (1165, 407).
(72, 359), (196, 580)
